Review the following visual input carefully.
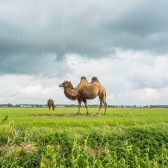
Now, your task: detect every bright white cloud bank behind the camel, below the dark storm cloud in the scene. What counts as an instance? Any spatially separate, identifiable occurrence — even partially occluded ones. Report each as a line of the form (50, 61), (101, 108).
(0, 50), (168, 105)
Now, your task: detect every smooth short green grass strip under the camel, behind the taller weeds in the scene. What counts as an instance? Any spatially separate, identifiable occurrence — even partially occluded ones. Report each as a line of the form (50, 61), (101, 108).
(0, 108), (168, 130)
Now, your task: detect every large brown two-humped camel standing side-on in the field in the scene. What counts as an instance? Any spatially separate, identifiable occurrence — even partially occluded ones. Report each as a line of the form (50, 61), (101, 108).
(59, 77), (107, 114)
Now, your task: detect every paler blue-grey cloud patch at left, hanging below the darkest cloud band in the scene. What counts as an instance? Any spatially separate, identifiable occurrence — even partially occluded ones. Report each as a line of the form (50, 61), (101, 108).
(0, 53), (70, 77)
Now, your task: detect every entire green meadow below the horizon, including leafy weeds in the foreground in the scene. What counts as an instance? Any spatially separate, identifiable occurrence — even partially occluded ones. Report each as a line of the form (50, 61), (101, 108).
(0, 108), (168, 168)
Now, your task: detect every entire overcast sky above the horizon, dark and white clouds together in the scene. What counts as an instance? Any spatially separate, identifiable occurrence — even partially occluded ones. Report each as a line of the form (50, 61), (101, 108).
(0, 0), (168, 105)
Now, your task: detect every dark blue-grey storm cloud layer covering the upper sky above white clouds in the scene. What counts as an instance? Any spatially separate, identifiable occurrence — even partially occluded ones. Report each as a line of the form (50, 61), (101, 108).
(0, 0), (168, 73)
